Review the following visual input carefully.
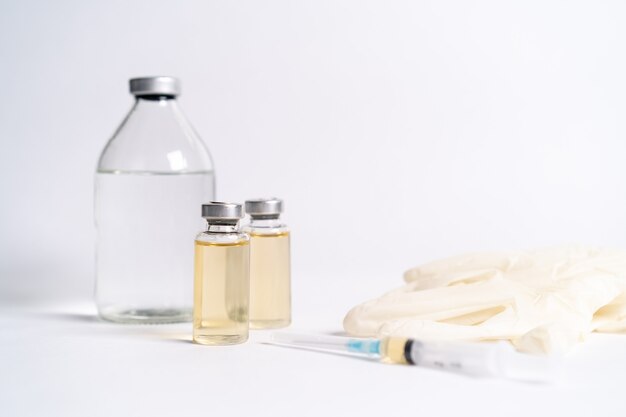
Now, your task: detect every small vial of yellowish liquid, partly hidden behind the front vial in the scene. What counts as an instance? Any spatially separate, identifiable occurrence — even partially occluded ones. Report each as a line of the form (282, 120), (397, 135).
(244, 198), (291, 329)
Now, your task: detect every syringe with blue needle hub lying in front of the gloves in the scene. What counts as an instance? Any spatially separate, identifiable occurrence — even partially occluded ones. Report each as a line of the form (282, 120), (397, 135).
(267, 333), (554, 382)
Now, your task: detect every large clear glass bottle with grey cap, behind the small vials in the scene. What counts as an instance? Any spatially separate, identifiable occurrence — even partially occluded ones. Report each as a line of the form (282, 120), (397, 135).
(95, 77), (215, 323)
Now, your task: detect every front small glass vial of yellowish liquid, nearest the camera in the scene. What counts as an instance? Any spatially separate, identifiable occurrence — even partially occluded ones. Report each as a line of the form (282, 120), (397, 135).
(193, 202), (250, 345)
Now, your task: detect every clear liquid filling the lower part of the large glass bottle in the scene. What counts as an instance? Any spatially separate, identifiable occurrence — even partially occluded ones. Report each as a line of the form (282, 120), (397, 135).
(95, 172), (214, 323)
